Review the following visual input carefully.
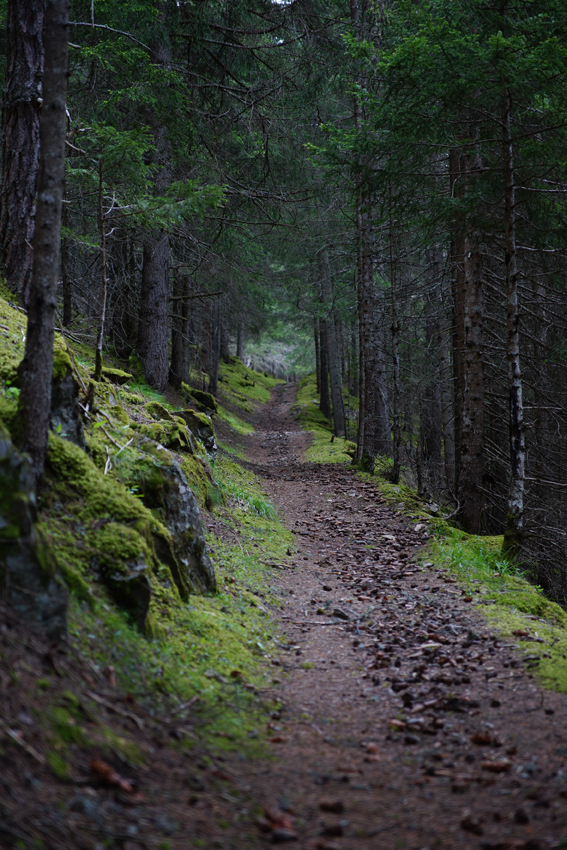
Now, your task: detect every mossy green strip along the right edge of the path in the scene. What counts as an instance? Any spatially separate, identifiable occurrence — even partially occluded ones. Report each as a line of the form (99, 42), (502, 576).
(296, 368), (567, 693)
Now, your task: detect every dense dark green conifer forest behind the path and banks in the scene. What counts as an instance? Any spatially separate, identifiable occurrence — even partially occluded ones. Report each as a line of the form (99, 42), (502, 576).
(0, 0), (567, 604)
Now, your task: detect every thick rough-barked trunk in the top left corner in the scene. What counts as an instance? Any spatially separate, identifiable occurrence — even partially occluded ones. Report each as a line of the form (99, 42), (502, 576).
(0, 0), (45, 306)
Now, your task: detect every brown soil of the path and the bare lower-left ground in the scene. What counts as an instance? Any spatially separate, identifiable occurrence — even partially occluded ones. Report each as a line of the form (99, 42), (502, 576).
(0, 386), (567, 850)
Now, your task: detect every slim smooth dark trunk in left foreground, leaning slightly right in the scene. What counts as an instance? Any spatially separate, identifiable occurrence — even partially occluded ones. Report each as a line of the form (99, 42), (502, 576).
(20, 0), (68, 477)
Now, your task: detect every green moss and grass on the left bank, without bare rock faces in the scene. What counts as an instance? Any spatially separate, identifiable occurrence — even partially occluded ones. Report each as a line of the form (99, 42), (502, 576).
(0, 299), (293, 760)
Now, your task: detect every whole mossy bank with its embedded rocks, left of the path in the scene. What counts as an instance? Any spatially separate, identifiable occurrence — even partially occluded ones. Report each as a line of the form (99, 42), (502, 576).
(0, 292), (300, 776)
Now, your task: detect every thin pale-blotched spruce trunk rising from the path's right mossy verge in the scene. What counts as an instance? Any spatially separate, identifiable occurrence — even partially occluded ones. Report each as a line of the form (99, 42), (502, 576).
(502, 91), (526, 557)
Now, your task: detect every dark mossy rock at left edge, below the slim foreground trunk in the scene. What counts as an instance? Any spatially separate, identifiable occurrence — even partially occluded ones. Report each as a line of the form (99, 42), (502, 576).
(0, 426), (68, 640)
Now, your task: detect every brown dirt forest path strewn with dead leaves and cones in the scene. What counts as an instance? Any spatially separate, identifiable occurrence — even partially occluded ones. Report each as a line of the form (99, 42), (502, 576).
(232, 385), (567, 850)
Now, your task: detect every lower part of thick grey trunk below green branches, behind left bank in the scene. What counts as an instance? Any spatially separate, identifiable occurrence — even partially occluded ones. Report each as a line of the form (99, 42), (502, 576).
(137, 231), (169, 392)
